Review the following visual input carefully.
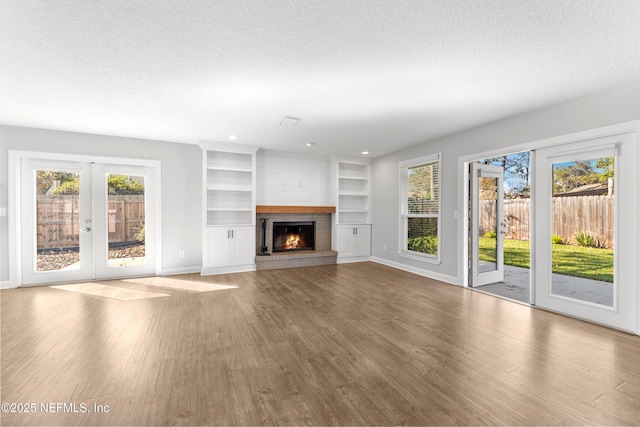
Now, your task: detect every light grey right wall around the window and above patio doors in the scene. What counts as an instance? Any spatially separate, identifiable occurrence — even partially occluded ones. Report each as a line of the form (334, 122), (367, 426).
(372, 80), (640, 283)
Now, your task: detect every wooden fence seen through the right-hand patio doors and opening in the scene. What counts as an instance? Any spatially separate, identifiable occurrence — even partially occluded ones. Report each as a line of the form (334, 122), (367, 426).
(480, 196), (614, 248)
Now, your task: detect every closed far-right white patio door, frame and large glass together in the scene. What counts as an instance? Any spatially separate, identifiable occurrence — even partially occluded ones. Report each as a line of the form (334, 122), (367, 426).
(534, 134), (638, 331)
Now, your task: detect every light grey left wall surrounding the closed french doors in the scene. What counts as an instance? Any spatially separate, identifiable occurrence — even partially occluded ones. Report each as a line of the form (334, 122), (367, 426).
(0, 126), (202, 282)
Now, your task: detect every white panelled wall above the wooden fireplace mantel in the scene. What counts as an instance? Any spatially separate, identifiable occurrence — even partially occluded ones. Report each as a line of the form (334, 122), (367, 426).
(256, 150), (330, 206)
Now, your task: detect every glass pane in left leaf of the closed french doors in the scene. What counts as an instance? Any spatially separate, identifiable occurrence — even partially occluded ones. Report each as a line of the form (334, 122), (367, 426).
(34, 170), (80, 271)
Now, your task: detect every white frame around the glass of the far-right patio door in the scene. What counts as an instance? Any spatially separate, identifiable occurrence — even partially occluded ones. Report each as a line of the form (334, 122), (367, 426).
(534, 133), (638, 331)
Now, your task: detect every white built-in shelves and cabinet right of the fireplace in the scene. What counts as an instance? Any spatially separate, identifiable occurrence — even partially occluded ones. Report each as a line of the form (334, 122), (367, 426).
(331, 156), (371, 262)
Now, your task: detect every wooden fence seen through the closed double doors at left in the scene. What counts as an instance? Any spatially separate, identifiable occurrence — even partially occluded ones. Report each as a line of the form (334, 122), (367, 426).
(37, 195), (144, 248)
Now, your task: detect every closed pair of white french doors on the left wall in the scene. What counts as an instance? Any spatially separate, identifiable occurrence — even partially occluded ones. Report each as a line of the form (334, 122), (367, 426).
(20, 158), (155, 285)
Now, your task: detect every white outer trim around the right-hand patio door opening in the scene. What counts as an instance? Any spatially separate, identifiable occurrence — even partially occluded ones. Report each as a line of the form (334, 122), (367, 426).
(455, 120), (640, 334)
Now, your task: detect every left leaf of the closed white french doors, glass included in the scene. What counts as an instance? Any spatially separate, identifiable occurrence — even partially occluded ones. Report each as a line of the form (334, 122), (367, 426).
(21, 160), (93, 284)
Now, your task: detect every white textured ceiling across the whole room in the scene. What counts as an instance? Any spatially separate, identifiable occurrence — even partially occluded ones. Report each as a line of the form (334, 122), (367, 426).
(0, 0), (640, 156)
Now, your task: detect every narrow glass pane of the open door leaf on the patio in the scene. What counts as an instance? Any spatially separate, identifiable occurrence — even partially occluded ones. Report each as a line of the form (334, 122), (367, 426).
(478, 177), (498, 273)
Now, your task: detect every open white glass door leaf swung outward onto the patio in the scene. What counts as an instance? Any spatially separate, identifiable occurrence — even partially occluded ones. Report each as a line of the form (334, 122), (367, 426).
(470, 163), (504, 287)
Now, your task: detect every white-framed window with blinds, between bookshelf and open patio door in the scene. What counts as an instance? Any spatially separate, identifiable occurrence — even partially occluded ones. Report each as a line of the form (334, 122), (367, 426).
(400, 154), (440, 263)
